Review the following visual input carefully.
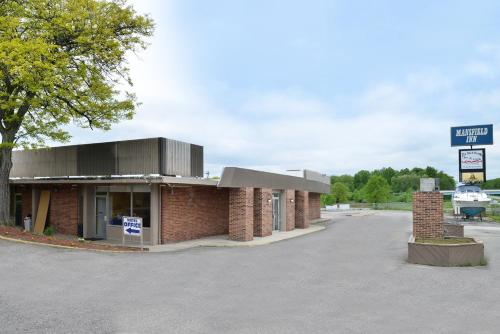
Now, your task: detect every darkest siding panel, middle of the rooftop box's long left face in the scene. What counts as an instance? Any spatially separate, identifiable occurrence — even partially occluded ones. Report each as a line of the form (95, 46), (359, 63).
(77, 142), (118, 176)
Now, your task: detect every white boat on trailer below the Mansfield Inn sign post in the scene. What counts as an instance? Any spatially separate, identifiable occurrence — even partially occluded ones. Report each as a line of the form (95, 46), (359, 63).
(451, 184), (491, 219)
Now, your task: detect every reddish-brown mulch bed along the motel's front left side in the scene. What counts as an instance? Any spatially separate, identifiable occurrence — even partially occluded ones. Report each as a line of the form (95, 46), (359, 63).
(0, 225), (145, 252)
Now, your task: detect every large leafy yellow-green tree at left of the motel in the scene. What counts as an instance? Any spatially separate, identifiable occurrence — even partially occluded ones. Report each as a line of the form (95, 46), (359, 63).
(0, 0), (153, 223)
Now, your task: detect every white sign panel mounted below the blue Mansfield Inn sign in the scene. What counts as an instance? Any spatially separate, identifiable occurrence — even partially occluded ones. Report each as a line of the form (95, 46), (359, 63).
(458, 148), (486, 183)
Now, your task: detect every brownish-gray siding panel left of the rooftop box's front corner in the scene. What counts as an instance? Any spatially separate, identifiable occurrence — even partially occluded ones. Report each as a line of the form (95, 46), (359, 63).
(117, 138), (160, 175)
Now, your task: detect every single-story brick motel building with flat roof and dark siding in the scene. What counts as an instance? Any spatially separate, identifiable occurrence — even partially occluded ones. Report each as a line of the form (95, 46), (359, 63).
(10, 138), (330, 245)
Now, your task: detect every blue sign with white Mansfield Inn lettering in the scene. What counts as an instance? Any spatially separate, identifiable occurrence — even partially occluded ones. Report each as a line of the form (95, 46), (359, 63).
(451, 124), (493, 146)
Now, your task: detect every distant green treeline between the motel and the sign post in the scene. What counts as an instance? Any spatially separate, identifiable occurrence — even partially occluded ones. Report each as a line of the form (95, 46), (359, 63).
(322, 167), (458, 205)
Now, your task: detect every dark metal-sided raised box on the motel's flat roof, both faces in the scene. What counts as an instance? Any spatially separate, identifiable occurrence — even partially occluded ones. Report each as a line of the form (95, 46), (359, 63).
(11, 138), (203, 177)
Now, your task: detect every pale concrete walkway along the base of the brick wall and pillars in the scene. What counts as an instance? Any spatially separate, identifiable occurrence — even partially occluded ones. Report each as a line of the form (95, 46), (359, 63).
(147, 224), (325, 252)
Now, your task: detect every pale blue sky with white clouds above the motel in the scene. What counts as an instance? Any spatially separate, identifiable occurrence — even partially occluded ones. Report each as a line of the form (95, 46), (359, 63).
(66, 0), (500, 177)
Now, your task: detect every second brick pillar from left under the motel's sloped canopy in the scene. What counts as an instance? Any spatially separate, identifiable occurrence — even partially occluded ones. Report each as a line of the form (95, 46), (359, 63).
(253, 188), (273, 237)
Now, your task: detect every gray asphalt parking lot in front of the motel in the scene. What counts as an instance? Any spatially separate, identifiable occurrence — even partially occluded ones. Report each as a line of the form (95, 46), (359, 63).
(0, 212), (500, 333)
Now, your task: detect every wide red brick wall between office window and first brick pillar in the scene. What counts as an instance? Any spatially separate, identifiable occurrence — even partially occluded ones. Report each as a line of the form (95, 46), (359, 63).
(161, 186), (229, 243)
